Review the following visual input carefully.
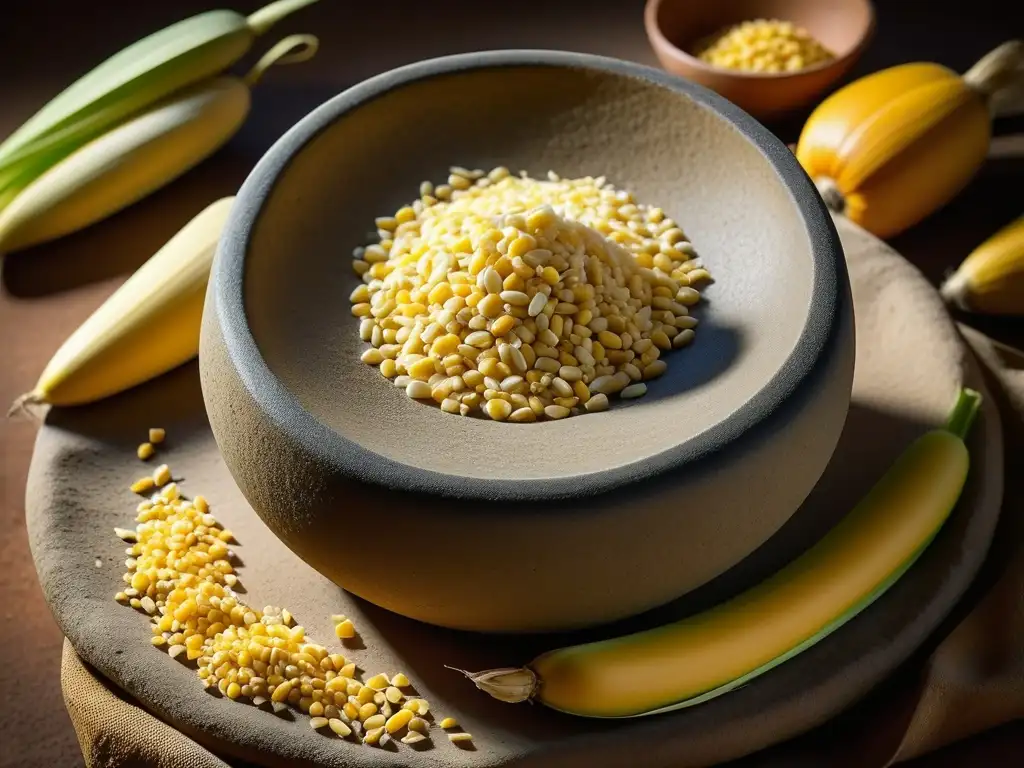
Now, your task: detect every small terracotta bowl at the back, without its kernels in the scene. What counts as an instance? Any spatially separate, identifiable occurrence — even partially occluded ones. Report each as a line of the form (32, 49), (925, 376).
(644, 0), (874, 120)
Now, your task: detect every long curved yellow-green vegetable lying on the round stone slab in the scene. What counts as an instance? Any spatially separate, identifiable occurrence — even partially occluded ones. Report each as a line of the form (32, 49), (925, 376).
(459, 390), (981, 718)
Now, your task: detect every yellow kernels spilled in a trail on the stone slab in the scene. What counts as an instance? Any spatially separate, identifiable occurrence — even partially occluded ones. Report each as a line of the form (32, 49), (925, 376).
(115, 430), (472, 746)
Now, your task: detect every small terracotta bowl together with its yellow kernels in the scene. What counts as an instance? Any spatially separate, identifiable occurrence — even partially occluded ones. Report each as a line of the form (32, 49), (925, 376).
(644, 0), (874, 119)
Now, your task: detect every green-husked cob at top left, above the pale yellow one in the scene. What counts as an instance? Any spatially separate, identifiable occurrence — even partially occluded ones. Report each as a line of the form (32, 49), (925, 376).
(0, 0), (315, 210)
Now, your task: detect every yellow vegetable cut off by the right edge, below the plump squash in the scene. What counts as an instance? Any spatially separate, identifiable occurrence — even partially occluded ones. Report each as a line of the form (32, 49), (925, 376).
(942, 216), (1024, 315)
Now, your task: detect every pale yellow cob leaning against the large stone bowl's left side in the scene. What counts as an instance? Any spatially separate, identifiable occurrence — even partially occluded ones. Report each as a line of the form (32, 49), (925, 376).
(11, 198), (234, 412)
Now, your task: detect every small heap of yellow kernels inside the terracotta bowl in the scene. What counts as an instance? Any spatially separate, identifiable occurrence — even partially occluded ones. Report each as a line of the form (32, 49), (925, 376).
(697, 18), (834, 72)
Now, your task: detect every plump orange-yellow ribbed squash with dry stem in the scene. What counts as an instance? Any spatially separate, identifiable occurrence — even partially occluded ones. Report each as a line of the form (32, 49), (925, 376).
(797, 41), (1024, 238)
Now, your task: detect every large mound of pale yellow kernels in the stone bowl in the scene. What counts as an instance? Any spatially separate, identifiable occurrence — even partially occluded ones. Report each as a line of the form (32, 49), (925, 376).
(350, 167), (711, 422)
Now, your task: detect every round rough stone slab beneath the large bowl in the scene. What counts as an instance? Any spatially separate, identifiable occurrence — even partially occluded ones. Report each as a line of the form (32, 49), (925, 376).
(28, 218), (1001, 768)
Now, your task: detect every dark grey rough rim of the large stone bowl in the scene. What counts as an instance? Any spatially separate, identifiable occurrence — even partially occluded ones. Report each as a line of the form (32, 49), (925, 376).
(210, 50), (850, 503)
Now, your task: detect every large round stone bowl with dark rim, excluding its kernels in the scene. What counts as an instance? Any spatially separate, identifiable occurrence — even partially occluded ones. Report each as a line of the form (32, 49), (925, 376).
(200, 51), (854, 632)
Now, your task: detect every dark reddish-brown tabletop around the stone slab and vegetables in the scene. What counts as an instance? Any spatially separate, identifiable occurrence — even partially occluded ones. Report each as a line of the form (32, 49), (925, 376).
(0, 0), (1024, 768)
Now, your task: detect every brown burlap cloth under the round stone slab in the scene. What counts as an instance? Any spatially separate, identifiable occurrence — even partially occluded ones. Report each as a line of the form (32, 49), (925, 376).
(54, 218), (1024, 768)
